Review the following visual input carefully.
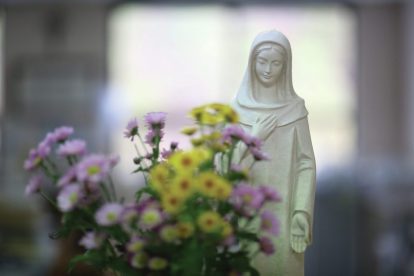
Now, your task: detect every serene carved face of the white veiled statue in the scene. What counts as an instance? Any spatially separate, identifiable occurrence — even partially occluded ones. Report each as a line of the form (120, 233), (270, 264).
(255, 49), (283, 87)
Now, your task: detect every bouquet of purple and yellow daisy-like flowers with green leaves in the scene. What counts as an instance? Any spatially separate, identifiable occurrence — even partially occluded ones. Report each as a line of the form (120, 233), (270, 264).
(24, 103), (280, 276)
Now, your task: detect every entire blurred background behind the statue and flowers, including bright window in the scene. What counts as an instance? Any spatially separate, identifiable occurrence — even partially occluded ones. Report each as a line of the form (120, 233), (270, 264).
(0, 0), (414, 276)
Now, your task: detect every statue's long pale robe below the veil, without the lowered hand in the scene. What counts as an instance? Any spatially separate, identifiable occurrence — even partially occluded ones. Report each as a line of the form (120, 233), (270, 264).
(234, 113), (315, 276)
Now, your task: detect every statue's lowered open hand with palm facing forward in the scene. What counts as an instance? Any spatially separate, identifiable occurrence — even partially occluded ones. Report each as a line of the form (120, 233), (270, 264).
(290, 212), (310, 253)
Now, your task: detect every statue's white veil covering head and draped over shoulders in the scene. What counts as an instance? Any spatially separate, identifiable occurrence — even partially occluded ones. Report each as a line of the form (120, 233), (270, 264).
(232, 30), (308, 126)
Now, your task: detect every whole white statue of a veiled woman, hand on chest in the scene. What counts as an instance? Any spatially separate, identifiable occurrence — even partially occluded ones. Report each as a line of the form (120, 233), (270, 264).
(232, 31), (316, 276)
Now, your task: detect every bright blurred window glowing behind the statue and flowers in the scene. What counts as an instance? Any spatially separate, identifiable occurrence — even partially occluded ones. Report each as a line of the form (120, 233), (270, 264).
(103, 4), (356, 190)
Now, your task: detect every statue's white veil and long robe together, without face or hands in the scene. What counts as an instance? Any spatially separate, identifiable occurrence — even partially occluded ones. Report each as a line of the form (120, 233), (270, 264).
(232, 31), (316, 276)
